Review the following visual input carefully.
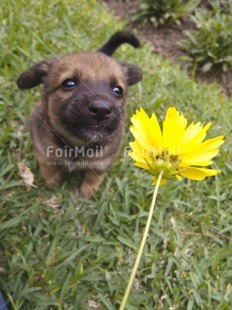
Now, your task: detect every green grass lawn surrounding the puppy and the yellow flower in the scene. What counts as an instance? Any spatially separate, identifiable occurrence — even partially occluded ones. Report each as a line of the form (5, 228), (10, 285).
(0, 0), (232, 310)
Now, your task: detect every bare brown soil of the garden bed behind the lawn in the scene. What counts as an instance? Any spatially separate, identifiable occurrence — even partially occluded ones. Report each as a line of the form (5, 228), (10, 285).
(102, 0), (232, 96)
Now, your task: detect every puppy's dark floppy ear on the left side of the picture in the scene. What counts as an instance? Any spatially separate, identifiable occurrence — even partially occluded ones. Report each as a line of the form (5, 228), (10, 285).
(17, 59), (53, 89)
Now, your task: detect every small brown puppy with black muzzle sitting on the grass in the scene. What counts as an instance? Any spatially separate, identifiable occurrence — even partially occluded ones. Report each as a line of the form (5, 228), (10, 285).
(17, 32), (142, 198)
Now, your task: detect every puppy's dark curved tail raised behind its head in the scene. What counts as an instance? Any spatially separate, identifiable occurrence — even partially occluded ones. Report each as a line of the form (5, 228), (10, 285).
(98, 31), (140, 56)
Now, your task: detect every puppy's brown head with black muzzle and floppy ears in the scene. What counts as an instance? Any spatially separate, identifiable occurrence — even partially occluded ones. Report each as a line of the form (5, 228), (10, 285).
(17, 52), (142, 141)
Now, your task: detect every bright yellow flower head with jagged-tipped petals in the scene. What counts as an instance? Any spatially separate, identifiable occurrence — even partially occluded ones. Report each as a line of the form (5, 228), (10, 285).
(129, 107), (224, 184)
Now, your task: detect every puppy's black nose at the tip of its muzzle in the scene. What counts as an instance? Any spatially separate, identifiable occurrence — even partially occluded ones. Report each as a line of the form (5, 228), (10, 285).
(89, 100), (112, 121)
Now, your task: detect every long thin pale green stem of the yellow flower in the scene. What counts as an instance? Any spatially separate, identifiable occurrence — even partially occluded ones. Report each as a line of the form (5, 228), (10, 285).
(119, 171), (163, 310)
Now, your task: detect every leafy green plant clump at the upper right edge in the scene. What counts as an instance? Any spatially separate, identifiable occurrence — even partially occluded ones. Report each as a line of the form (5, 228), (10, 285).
(180, 1), (232, 72)
